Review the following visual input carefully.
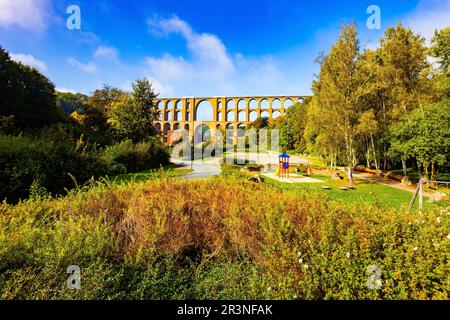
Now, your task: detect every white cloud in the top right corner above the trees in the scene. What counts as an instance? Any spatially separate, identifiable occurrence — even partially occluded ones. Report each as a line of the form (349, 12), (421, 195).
(404, 0), (450, 41)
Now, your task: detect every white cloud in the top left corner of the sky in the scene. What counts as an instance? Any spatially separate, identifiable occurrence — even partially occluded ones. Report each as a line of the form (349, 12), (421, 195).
(0, 0), (52, 31)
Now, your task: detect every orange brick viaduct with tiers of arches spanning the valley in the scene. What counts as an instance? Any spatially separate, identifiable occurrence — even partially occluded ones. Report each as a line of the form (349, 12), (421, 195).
(154, 96), (308, 143)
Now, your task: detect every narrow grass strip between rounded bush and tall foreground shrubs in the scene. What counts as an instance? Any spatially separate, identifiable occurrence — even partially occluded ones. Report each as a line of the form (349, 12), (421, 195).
(110, 164), (192, 184)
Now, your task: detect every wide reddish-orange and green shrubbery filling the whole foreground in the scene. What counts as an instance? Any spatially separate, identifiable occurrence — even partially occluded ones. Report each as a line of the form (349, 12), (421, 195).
(0, 178), (450, 300)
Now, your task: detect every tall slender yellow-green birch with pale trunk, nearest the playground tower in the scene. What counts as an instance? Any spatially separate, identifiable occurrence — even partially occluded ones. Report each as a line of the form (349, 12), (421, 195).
(313, 23), (369, 184)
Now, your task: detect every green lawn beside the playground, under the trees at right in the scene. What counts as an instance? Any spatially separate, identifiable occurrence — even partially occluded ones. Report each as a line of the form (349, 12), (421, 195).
(264, 175), (448, 209)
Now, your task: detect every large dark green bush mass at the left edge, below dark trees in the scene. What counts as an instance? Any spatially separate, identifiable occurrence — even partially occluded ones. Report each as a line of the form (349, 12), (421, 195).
(0, 129), (107, 202)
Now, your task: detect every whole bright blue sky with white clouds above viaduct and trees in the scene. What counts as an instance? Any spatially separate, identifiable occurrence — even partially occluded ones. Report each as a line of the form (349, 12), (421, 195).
(0, 0), (450, 97)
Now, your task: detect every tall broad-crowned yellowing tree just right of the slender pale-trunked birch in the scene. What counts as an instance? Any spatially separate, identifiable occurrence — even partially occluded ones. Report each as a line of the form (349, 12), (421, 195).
(363, 24), (432, 172)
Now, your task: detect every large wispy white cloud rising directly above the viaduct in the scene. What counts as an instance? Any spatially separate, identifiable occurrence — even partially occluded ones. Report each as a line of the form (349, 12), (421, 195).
(145, 16), (298, 96)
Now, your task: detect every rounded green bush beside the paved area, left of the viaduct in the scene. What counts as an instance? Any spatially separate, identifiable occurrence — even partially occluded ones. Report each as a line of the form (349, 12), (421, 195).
(103, 138), (169, 174)
